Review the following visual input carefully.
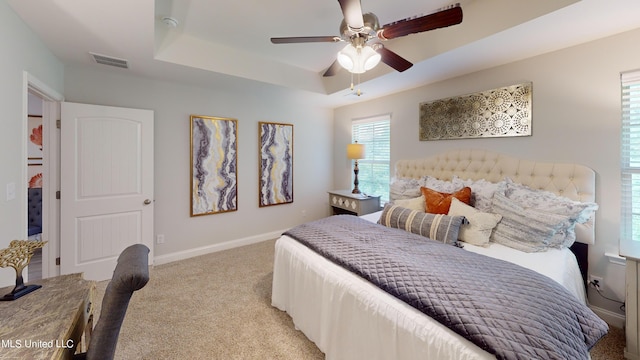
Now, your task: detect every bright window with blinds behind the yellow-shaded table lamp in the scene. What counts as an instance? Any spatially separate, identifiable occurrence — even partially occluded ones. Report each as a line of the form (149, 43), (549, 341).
(351, 115), (391, 203)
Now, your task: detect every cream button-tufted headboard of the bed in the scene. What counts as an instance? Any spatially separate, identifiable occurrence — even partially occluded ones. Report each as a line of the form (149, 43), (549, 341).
(395, 150), (596, 244)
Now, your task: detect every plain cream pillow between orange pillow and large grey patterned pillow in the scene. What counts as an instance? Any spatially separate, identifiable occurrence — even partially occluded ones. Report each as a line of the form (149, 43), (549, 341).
(449, 198), (502, 246)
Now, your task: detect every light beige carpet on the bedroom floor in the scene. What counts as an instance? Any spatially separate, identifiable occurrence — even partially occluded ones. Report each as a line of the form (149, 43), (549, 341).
(96, 240), (624, 360)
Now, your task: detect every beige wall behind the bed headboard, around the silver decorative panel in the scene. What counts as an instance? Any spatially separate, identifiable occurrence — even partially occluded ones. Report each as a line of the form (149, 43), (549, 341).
(333, 26), (640, 313)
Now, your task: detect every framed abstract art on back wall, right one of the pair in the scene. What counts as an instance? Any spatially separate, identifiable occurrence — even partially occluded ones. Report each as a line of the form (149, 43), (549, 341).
(258, 122), (293, 207)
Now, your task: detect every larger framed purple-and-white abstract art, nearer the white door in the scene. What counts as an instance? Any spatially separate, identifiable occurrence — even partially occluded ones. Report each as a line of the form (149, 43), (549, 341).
(191, 115), (238, 216)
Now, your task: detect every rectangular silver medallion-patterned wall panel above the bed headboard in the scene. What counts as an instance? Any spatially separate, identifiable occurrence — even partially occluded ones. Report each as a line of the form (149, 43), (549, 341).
(420, 83), (532, 141)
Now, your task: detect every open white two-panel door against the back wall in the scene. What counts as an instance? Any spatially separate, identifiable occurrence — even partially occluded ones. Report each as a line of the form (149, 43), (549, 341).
(60, 103), (153, 280)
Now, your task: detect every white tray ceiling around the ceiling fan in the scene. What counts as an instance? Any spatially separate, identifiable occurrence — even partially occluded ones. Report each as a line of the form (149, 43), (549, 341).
(8, 0), (640, 106)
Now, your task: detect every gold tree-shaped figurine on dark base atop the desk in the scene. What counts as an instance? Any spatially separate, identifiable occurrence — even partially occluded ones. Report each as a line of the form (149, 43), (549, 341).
(0, 240), (47, 301)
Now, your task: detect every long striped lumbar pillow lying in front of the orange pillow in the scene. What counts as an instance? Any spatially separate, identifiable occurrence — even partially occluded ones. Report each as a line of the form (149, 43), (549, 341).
(378, 204), (464, 246)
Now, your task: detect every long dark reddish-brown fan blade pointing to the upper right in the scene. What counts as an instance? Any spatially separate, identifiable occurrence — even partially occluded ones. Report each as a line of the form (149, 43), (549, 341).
(378, 4), (462, 40)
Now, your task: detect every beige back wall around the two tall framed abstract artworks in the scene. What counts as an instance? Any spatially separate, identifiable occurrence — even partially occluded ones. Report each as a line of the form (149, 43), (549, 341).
(64, 67), (333, 262)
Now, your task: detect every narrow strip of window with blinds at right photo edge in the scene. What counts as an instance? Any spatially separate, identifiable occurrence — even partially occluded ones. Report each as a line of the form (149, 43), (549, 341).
(620, 71), (640, 256)
